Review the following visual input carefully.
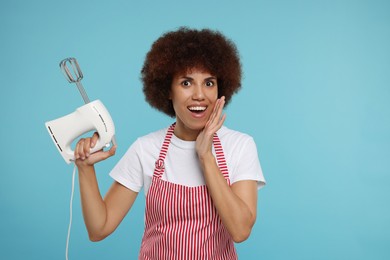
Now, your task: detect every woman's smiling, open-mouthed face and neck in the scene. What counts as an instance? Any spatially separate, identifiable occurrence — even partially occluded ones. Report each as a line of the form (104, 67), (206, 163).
(170, 68), (218, 141)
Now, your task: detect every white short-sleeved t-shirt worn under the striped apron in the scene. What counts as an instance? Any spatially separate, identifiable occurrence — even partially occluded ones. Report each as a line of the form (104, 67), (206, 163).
(110, 126), (265, 196)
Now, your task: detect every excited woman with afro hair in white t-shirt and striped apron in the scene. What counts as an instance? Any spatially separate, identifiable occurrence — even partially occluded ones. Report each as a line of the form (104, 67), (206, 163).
(75, 28), (265, 259)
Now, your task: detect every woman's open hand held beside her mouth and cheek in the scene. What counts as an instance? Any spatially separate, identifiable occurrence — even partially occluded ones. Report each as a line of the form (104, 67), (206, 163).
(195, 96), (226, 160)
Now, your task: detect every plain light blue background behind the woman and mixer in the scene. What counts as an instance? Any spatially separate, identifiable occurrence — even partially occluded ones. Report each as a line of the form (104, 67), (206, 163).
(0, 0), (390, 259)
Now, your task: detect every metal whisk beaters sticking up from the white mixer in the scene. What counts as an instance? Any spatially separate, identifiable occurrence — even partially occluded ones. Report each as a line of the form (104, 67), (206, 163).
(60, 58), (90, 104)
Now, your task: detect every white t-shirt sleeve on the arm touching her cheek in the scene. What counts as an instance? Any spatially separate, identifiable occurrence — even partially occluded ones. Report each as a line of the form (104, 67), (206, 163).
(231, 137), (266, 189)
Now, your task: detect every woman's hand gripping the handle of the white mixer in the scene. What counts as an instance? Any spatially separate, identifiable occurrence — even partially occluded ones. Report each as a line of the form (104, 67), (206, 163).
(74, 132), (116, 168)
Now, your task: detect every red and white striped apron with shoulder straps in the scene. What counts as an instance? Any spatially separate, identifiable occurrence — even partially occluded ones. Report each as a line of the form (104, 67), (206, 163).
(139, 124), (237, 260)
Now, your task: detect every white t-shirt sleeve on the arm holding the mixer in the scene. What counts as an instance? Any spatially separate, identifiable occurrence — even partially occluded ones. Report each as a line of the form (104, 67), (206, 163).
(110, 140), (143, 192)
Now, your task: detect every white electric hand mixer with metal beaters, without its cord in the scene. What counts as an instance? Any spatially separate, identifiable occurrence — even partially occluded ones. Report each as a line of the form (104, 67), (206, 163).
(45, 58), (116, 164)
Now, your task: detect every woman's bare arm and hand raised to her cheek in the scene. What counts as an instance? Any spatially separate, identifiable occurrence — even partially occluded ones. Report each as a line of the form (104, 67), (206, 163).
(196, 97), (257, 242)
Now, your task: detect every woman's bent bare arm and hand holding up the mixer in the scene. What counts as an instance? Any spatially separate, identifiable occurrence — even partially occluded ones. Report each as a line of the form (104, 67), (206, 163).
(75, 134), (138, 241)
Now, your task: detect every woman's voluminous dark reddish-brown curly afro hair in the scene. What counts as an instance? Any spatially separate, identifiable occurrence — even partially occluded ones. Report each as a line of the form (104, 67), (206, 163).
(141, 27), (241, 117)
